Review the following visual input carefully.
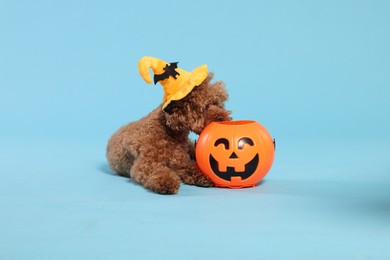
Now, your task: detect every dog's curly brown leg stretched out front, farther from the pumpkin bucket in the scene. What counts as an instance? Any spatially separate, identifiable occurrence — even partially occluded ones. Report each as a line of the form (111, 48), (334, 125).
(130, 158), (181, 194)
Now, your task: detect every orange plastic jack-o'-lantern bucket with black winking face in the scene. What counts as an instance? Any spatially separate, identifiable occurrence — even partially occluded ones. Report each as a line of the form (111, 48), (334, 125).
(195, 120), (275, 188)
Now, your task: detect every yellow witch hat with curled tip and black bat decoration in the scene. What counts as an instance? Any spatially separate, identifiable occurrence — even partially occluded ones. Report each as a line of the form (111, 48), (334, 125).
(138, 56), (207, 109)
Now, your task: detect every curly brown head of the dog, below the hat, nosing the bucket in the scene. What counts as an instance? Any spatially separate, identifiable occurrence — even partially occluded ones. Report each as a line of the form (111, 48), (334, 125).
(164, 73), (231, 134)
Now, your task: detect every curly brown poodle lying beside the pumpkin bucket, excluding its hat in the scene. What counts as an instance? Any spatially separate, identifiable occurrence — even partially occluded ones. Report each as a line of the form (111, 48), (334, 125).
(107, 73), (231, 194)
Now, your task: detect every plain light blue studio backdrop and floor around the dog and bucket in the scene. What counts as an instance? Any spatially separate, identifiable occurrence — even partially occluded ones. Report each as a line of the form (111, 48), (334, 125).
(0, 1), (390, 259)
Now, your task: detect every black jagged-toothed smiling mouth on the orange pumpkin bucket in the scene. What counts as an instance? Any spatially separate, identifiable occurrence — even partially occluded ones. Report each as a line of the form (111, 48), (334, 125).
(209, 154), (259, 181)
